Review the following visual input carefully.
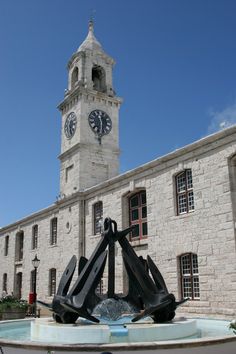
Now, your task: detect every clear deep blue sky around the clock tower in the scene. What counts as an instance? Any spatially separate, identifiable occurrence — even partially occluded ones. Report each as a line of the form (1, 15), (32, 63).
(0, 0), (236, 226)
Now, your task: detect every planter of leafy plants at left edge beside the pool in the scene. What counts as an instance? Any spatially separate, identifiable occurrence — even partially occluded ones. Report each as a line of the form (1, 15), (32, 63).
(0, 295), (28, 320)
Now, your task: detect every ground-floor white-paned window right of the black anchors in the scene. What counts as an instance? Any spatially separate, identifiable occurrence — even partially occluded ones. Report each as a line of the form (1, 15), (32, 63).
(180, 253), (200, 300)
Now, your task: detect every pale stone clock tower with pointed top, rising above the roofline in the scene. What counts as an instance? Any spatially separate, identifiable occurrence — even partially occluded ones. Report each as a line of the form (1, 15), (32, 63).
(58, 21), (122, 196)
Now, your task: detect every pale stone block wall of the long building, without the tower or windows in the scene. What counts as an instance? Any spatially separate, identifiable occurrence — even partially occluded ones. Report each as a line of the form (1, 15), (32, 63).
(0, 128), (236, 318)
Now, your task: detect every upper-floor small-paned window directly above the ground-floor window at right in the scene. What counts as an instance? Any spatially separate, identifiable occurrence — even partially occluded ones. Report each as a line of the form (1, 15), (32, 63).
(175, 170), (194, 215)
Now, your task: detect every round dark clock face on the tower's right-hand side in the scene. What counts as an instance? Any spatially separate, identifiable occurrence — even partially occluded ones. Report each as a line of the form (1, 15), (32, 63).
(88, 109), (112, 137)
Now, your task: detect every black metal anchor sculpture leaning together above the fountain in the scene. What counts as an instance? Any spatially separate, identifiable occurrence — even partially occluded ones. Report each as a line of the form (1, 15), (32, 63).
(38, 218), (188, 323)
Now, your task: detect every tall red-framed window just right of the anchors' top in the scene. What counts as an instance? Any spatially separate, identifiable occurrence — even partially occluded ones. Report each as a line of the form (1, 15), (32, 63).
(129, 191), (148, 241)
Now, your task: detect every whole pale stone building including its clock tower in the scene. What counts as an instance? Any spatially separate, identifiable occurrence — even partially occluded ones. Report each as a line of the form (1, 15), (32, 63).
(0, 23), (236, 318)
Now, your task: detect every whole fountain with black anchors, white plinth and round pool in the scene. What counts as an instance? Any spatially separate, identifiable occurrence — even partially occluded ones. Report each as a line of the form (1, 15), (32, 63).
(0, 218), (236, 354)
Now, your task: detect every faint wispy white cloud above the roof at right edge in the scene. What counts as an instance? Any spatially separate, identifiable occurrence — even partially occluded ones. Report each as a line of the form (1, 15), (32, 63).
(208, 103), (236, 134)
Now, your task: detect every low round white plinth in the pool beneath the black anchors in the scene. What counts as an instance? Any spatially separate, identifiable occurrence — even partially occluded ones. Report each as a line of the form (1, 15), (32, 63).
(31, 318), (198, 344)
